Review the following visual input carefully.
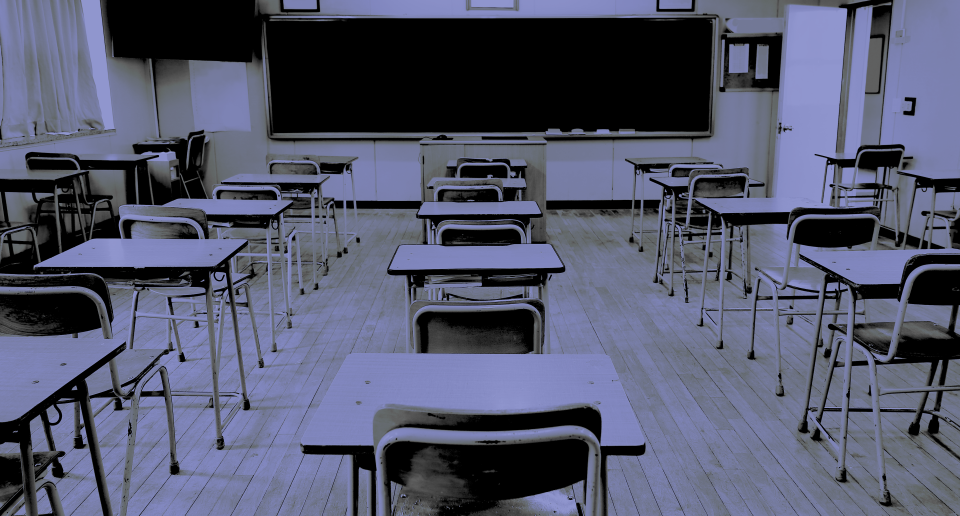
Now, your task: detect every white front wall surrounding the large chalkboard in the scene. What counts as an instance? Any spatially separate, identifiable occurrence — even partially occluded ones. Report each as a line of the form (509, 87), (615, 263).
(146, 0), (838, 201)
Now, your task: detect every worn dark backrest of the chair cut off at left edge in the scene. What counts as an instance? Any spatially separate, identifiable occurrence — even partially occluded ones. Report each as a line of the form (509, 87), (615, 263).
(0, 274), (113, 339)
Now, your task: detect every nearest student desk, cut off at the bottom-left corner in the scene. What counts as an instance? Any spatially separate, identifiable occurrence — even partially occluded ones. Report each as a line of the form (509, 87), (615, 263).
(0, 337), (126, 516)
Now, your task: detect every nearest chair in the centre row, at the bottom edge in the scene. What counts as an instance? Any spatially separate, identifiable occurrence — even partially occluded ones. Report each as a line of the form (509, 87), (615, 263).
(373, 404), (606, 516)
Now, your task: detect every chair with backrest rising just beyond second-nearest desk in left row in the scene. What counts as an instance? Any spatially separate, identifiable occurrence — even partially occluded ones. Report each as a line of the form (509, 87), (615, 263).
(117, 204), (266, 366)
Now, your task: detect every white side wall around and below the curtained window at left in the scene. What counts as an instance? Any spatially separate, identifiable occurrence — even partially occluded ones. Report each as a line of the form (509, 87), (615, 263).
(0, 1), (156, 252)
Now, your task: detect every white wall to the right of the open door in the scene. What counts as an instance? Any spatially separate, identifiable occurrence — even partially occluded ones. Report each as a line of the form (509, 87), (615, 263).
(881, 0), (960, 245)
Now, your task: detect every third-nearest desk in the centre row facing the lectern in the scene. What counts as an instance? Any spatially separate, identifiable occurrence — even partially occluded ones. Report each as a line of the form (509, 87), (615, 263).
(417, 201), (543, 244)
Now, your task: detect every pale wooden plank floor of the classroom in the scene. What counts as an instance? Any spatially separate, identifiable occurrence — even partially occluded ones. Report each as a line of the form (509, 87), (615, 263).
(0, 210), (960, 516)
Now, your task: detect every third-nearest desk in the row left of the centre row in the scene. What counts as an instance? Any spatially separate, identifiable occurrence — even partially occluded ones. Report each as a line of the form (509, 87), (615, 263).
(164, 199), (293, 351)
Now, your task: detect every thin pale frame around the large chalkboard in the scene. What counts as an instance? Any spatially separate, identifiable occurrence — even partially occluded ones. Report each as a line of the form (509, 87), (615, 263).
(261, 14), (720, 140)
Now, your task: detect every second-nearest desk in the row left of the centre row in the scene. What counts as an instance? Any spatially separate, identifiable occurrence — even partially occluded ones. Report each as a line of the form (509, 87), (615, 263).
(34, 238), (250, 450)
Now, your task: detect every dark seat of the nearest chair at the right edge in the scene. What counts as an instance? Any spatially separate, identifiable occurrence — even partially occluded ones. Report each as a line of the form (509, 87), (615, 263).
(829, 321), (960, 360)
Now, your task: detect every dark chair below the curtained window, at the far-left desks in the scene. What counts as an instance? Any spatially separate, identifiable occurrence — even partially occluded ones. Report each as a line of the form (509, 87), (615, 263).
(26, 152), (116, 240)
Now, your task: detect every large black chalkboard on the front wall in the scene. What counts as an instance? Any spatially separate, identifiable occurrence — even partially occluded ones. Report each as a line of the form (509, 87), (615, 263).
(264, 16), (717, 138)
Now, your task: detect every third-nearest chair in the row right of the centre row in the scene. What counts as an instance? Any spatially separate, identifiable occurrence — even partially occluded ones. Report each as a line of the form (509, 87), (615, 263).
(658, 168), (750, 303)
